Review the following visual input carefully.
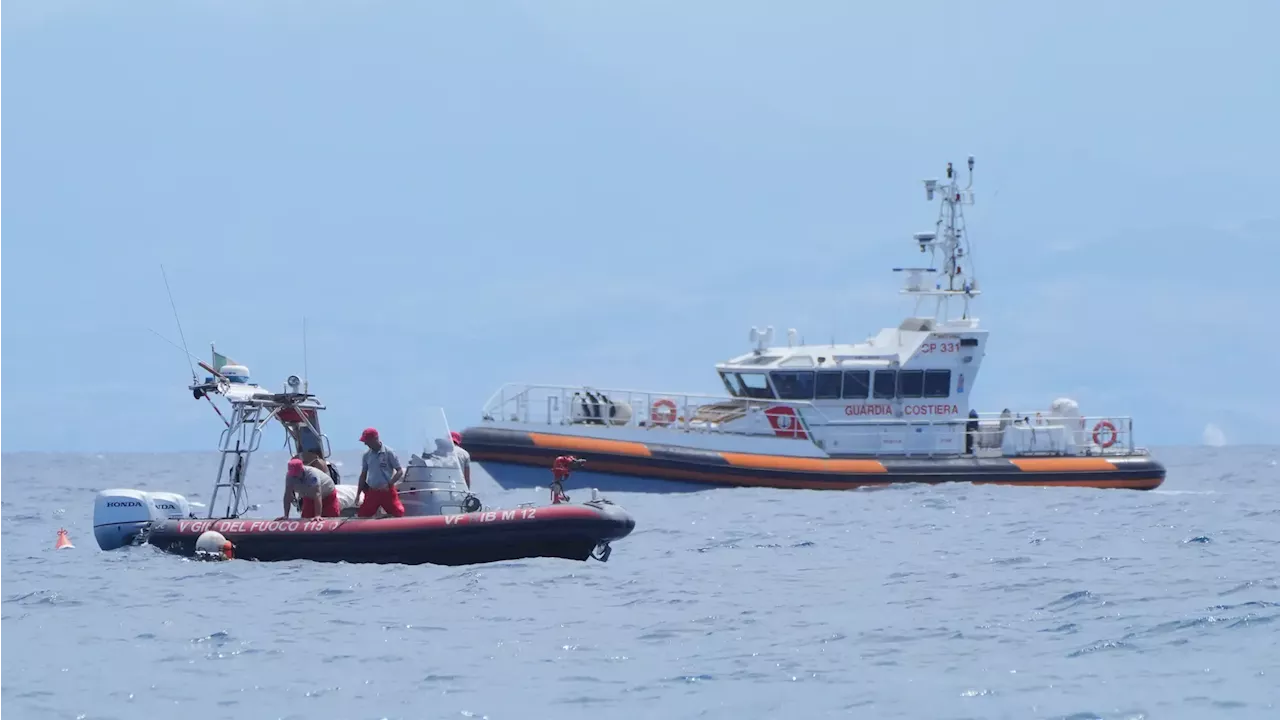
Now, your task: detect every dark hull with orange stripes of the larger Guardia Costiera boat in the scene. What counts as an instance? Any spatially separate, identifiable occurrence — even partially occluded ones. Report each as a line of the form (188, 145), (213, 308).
(462, 427), (1165, 489)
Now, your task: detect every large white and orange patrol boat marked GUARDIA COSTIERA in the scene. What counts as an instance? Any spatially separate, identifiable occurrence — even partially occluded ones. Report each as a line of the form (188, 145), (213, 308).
(462, 156), (1165, 489)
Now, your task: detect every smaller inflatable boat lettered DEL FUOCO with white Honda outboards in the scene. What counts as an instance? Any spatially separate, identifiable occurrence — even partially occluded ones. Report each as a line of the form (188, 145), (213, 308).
(93, 354), (635, 565)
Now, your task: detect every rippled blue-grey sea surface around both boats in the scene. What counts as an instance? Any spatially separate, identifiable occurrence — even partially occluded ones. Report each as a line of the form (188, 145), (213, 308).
(0, 447), (1280, 720)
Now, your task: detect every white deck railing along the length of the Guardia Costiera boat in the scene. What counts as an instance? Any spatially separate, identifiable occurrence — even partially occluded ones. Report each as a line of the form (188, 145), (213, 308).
(484, 384), (1138, 456)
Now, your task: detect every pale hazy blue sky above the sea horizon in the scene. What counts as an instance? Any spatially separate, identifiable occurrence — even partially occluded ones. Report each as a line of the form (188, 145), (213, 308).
(0, 0), (1280, 451)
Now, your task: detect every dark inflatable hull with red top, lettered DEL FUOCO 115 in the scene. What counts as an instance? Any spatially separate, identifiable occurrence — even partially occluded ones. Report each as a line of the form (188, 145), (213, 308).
(147, 502), (635, 565)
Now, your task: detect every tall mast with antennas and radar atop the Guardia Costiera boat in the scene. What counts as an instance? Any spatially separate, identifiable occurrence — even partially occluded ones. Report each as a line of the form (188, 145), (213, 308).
(893, 155), (979, 322)
